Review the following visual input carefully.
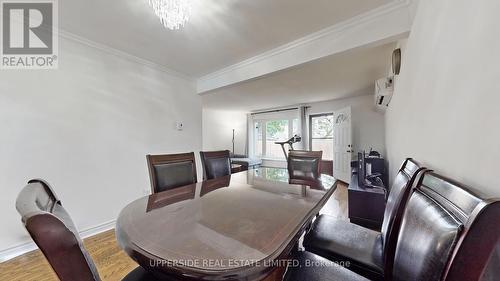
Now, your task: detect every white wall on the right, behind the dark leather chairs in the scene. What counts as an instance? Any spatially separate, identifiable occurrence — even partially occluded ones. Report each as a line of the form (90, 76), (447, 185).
(386, 0), (500, 196)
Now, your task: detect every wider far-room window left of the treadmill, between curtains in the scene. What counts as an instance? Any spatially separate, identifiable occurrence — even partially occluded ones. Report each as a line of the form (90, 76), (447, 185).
(254, 118), (299, 160)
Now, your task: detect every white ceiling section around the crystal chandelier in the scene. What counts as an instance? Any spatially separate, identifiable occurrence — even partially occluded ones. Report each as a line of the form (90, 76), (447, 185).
(59, 0), (392, 77)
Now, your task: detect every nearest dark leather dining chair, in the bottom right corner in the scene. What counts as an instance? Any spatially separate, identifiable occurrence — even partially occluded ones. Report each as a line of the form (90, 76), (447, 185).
(283, 168), (500, 281)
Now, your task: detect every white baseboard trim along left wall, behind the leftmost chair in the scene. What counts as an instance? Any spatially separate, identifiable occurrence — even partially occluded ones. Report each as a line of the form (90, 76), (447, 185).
(0, 220), (116, 263)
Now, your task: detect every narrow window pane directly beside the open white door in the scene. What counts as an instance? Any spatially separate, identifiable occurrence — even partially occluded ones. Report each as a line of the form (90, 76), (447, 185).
(309, 113), (333, 160)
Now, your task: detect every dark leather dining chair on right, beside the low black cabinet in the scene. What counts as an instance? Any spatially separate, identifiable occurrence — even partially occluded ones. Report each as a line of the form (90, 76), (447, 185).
(303, 158), (424, 279)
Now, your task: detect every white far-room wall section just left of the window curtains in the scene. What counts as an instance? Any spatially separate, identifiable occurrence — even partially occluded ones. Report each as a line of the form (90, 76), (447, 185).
(203, 108), (247, 154)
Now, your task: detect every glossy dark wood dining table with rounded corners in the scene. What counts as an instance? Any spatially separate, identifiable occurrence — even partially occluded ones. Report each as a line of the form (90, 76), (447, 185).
(116, 168), (336, 280)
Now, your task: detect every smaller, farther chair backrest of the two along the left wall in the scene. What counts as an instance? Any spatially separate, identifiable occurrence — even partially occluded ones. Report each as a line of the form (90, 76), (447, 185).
(200, 150), (231, 180)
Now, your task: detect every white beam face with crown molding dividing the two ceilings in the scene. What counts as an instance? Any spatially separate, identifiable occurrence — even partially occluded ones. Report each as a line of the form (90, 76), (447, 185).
(197, 0), (415, 94)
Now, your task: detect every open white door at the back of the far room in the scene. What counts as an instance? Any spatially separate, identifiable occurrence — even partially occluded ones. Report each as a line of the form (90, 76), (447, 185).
(333, 107), (354, 183)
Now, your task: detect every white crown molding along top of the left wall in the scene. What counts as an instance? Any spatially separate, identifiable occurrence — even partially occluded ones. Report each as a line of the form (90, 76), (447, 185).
(56, 29), (195, 82)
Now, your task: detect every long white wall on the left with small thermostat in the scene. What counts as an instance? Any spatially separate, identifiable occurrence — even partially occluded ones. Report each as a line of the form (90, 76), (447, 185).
(0, 35), (201, 253)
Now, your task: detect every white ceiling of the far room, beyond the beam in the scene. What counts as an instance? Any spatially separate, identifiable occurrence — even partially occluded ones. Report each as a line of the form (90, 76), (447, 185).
(202, 43), (395, 111)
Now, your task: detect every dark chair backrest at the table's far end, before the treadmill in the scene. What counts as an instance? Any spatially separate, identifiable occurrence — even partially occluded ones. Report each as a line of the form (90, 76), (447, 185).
(287, 150), (323, 184)
